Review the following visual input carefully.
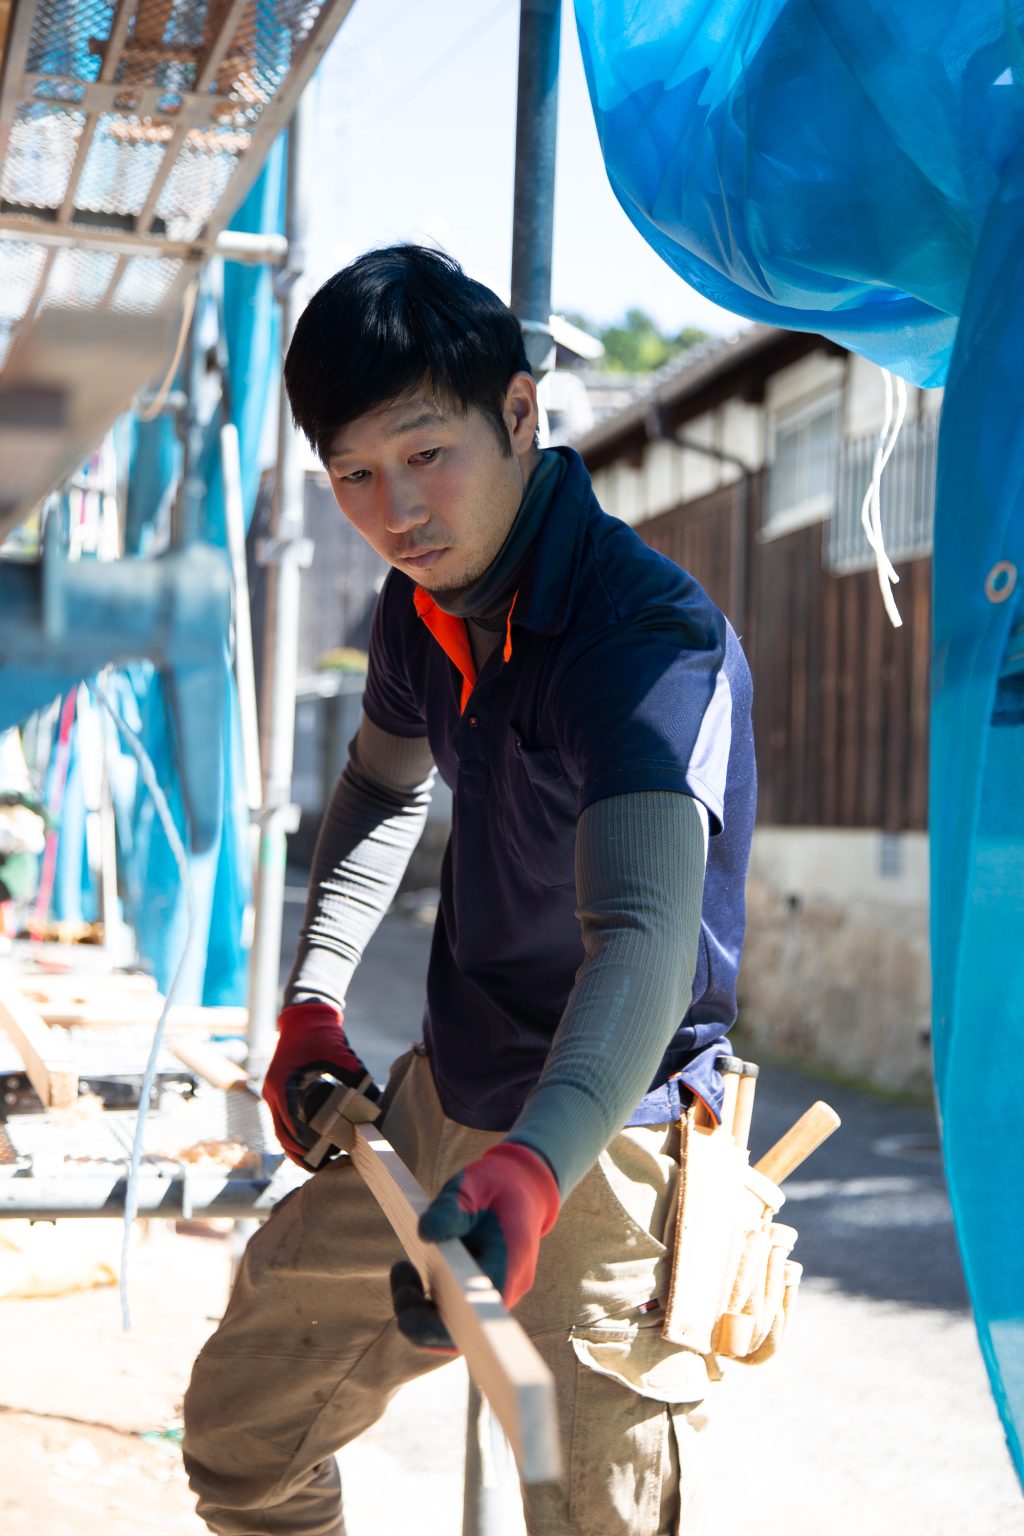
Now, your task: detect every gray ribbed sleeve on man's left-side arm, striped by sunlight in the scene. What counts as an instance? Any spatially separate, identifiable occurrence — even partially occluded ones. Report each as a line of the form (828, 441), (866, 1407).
(284, 714), (434, 1008)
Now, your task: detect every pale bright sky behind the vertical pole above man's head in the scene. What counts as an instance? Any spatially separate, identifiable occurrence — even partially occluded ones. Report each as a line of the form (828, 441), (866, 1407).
(309, 0), (745, 335)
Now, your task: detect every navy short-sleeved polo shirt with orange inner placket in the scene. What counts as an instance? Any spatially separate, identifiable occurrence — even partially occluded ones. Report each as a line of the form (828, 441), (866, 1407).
(364, 449), (755, 1130)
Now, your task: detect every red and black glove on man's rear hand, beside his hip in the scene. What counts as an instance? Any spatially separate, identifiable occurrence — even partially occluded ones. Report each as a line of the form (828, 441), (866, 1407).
(263, 1003), (379, 1167)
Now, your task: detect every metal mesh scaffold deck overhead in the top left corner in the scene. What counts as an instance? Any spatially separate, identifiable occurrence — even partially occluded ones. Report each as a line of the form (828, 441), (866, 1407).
(0, 0), (352, 246)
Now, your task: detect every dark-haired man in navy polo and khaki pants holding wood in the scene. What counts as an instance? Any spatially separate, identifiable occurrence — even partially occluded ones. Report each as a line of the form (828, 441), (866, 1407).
(186, 246), (754, 1536)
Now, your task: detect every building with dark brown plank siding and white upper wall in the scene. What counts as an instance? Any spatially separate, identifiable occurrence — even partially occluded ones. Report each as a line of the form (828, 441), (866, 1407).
(574, 326), (941, 1087)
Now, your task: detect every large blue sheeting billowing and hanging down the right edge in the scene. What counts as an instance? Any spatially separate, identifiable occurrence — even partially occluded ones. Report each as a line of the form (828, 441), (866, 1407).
(576, 0), (1024, 1478)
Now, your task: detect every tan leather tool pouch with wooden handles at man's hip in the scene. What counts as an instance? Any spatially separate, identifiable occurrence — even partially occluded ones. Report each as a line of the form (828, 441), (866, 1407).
(662, 1057), (840, 1366)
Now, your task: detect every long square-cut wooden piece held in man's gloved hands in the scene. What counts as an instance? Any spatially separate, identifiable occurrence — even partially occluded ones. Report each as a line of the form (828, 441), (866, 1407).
(350, 1126), (562, 1484)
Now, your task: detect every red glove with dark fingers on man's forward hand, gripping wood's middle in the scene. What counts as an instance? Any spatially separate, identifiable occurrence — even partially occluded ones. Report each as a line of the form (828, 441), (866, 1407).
(391, 1141), (559, 1350)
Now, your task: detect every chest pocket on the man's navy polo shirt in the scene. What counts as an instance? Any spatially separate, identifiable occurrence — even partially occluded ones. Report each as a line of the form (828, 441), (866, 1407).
(503, 727), (576, 888)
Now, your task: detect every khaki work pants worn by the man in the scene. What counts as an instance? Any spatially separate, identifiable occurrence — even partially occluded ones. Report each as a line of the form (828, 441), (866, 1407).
(184, 1051), (708, 1536)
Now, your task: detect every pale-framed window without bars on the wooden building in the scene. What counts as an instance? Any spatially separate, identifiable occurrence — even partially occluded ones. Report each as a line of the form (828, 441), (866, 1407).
(761, 393), (840, 539)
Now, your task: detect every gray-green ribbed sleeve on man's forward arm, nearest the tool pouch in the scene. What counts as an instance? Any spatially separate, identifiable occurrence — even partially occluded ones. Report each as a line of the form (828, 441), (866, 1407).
(508, 790), (708, 1200)
